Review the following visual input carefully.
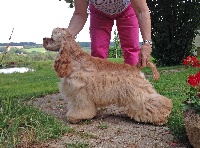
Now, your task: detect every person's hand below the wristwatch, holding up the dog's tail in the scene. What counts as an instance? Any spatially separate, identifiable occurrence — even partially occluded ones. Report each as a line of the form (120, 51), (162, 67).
(137, 44), (151, 69)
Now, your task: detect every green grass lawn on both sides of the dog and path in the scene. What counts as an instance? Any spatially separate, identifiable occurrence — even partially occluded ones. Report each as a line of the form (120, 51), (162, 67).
(0, 59), (198, 147)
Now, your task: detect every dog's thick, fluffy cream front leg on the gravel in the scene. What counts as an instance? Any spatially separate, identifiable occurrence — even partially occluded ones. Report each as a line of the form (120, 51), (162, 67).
(66, 92), (96, 123)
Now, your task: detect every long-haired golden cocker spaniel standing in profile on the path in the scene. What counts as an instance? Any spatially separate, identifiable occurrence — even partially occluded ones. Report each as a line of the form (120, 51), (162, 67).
(43, 28), (172, 125)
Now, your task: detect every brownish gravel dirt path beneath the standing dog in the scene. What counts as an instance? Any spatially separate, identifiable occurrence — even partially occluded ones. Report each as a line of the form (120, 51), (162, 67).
(27, 94), (188, 148)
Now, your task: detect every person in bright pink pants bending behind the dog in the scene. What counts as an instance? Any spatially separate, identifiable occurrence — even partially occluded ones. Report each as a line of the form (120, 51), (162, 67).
(68, 0), (151, 69)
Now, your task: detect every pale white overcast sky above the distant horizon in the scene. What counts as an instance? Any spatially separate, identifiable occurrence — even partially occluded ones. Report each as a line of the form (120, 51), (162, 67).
(0, 0), (141, 44)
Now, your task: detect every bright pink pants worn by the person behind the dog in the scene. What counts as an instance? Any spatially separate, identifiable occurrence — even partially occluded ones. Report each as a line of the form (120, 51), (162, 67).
(90, 4), (140, 65)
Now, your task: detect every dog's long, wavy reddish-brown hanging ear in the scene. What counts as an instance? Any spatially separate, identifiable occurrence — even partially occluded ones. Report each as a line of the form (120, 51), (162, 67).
(54, 42), (72, 78)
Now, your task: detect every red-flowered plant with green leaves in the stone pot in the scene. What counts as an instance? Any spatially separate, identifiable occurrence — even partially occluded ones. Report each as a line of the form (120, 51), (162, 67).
(183, 56), (200, 114)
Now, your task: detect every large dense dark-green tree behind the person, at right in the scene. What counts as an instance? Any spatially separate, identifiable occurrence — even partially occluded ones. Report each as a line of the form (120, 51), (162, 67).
(147, 0), (200, 66)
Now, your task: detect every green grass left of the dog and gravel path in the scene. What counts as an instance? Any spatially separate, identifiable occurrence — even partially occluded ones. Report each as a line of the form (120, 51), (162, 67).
(0, 61), (69, 147)
